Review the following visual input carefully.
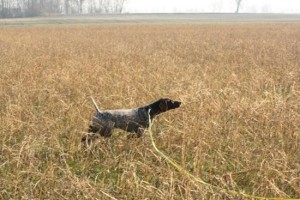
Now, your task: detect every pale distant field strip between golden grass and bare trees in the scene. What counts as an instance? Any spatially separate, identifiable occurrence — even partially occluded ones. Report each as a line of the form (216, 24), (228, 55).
(0, 13), (300, 27)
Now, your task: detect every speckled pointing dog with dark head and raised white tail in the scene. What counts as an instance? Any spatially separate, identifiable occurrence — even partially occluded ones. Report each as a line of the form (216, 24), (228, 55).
(82, 98), (181, 143)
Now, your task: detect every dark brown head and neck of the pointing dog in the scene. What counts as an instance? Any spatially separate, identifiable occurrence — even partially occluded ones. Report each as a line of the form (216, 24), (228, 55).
(147, 98), (181, 119)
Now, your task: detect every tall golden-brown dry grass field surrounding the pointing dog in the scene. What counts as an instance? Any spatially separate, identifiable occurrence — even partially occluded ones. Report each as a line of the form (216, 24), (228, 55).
(0, 23), (300, 199)
